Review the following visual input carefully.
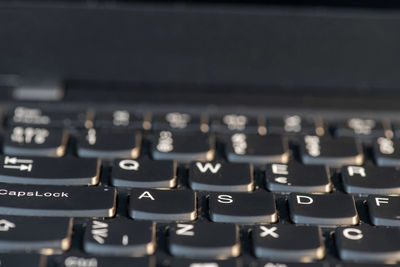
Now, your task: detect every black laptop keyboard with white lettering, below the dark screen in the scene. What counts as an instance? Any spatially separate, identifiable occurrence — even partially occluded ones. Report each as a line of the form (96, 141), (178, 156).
(0, 105), (400, 267)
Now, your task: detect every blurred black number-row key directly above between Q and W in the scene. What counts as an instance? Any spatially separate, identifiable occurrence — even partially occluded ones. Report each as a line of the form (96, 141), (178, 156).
(152, 131), (215, 162)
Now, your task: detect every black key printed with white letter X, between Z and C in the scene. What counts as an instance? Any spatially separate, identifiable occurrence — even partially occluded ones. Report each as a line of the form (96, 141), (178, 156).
(252, 224), (325, 262)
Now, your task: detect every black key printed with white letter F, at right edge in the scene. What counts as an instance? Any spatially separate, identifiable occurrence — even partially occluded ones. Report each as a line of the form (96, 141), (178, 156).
(368, 195), (400, 227)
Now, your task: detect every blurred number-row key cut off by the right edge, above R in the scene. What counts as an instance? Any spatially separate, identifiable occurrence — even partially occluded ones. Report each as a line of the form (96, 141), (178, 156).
(373, 137), (400, 167)
